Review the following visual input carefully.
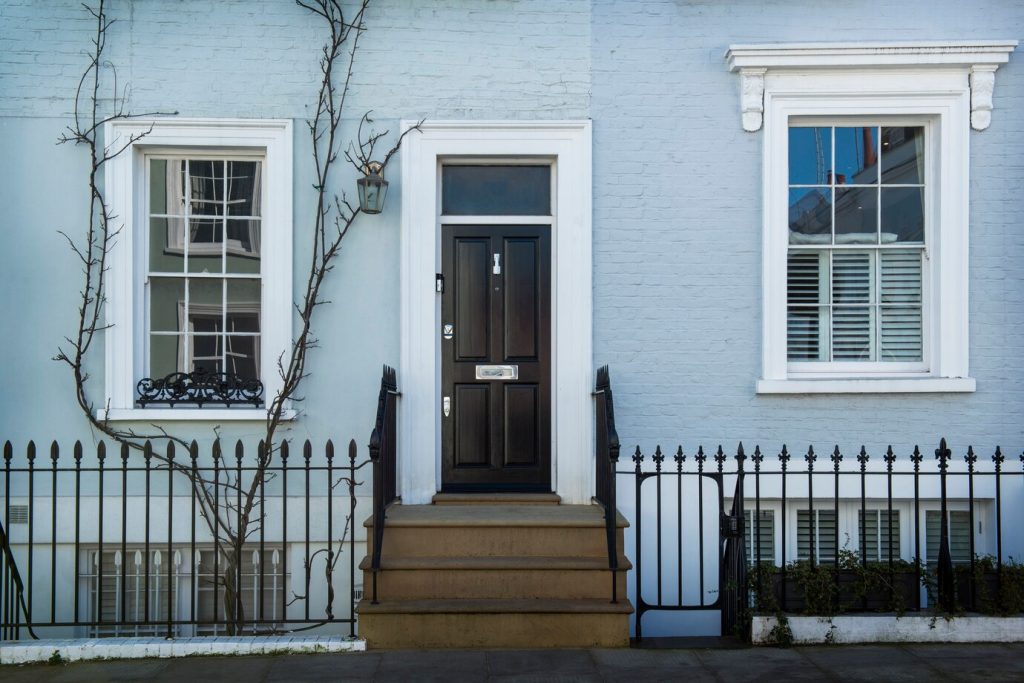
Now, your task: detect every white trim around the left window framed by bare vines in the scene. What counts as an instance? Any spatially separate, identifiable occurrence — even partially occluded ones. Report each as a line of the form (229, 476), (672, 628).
(97, 118), (295, 422)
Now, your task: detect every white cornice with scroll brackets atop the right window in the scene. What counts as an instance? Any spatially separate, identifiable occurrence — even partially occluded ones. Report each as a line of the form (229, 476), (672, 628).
(725, 40), (1017, 132)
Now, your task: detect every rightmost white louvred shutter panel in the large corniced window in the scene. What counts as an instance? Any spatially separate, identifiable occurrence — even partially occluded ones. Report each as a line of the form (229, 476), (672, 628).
(879, 250), (923, 362)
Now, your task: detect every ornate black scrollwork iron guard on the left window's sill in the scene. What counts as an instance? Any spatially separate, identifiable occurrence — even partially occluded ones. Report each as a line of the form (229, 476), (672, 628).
(135, 370), (263, 408)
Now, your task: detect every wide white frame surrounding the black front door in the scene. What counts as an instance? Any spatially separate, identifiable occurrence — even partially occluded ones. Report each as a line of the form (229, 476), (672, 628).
(398, 121), (594, 505)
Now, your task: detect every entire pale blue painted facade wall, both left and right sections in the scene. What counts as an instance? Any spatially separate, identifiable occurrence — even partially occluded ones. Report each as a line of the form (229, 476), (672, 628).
(0, 0), (1024, 452)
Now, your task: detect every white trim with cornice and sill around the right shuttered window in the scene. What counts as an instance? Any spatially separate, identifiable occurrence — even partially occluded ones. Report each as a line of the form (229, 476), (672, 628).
(726, 41), (1017, 394)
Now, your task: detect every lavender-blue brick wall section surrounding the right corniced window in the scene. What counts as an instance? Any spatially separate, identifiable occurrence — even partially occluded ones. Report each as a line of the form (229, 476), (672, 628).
(592, 1), (1024, 459)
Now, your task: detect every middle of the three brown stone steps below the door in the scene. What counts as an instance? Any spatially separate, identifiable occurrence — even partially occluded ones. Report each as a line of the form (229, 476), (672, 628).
(359, 556), (631, 600)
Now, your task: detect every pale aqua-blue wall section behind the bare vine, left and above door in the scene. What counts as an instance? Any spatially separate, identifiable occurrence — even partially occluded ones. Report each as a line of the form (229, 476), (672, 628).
(0, 0), (591, 453)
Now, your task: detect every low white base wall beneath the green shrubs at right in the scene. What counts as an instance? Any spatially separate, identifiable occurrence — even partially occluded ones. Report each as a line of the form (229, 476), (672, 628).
(751, 615), (1024, 645)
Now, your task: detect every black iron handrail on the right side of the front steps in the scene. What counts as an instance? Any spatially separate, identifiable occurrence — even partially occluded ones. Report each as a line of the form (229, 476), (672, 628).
(594, 366), (620, 602)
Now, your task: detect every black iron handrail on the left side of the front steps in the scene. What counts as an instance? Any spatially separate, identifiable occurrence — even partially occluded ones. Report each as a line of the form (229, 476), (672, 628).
(370, 366), (401, 604)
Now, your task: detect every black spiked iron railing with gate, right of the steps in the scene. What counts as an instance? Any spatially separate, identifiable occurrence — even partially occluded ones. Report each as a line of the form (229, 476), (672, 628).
(617, 438), (1024, 637)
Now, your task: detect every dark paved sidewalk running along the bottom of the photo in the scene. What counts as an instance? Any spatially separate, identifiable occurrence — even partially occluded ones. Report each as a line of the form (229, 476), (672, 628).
(0, 644), (1024, 683)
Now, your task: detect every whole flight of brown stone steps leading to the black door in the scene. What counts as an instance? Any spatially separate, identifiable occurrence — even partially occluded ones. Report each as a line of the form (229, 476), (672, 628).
(358, 494), (633, 648)
